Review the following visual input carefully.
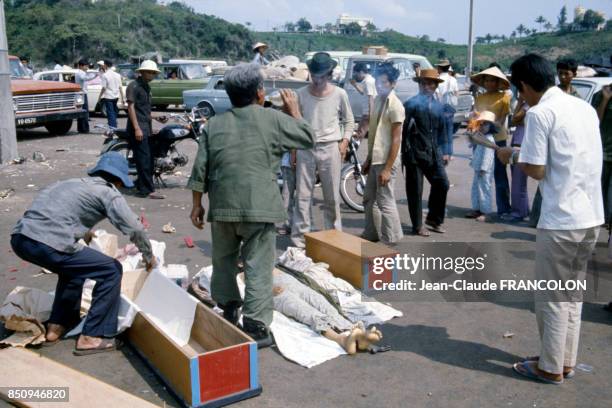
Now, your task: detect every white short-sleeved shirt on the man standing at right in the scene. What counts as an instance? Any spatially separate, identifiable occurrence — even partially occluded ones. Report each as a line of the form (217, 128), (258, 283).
(519, 87), (604, 230)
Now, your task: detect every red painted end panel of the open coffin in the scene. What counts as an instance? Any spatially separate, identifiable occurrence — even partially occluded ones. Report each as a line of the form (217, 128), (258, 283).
(198, 344), (251, 403)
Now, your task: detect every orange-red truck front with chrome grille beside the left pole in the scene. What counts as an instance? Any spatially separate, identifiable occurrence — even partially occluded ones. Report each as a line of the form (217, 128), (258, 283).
(9, 56), (86, 135)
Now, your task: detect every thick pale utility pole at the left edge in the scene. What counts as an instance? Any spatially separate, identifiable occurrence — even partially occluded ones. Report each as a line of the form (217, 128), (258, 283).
(0, 0), (17, 164)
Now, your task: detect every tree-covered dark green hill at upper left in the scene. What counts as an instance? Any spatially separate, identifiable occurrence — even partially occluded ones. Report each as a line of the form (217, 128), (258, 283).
(6, 0), (254, 66)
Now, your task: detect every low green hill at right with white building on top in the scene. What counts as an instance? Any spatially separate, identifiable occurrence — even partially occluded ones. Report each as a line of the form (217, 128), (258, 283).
(256, 30), (612, 69)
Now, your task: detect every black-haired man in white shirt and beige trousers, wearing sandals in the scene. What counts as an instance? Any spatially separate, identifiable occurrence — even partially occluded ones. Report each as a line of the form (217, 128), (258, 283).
(497, 54), (604, 384)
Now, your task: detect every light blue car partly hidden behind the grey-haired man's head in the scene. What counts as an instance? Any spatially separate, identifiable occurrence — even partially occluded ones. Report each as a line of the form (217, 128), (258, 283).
(183, 75), (308, 118)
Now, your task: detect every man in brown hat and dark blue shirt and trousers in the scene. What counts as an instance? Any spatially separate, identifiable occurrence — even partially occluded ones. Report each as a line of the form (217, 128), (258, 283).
(402, 69), (452, 237)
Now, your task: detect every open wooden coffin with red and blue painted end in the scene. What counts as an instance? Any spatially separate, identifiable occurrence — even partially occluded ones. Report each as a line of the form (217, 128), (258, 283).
(121, 270), (261, 407)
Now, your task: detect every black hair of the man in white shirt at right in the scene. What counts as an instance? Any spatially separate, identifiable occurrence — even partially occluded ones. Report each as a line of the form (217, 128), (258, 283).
(510, 54), (555, 92)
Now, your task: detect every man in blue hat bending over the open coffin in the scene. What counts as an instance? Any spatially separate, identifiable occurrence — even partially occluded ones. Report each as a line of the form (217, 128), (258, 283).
(11, 152), (156, 355)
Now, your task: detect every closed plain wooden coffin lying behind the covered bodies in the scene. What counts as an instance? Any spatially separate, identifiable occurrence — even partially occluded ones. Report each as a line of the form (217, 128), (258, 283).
(305, 230), (397, 291)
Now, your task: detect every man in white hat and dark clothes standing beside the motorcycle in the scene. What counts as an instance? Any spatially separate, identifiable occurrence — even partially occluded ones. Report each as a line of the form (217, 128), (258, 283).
(126, 60), (167, 199)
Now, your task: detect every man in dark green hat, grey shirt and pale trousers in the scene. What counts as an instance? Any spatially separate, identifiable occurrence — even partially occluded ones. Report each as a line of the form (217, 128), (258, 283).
(291, 52), (355, 247)
